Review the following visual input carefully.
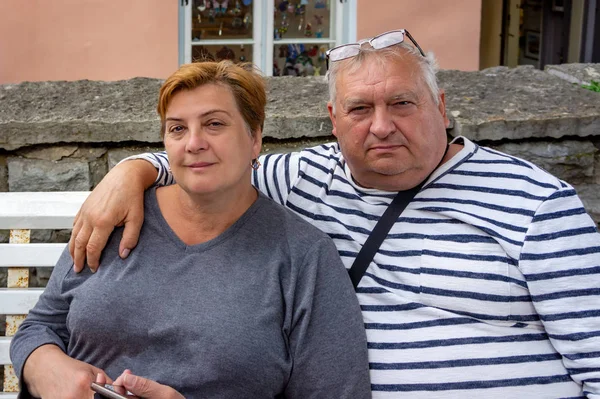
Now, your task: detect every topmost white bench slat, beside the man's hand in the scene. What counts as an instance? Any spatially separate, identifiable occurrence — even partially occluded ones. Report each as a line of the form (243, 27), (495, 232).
(0, 191), (90, 229)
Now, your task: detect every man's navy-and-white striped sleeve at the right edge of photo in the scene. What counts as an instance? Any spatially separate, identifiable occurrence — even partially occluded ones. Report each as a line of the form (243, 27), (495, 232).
(519, 185), (600, 397)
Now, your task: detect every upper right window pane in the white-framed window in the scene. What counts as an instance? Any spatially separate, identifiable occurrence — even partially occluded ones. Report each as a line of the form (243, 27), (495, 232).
(273, 0), (334, 40)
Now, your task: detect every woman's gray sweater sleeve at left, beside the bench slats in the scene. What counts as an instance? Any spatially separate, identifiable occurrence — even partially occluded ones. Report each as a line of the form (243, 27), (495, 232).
(10, 247), (75, 392)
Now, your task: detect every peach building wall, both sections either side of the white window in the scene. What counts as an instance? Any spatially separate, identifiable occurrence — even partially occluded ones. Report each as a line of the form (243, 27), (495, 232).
(0, 0), (481, 84)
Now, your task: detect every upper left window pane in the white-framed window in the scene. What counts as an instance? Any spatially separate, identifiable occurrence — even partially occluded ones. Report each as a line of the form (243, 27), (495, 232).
(192, 0), (253, 43)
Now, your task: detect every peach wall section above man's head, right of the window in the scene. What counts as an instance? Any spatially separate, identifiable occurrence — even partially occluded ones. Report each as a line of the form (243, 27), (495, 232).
(356, 0), (482, 71)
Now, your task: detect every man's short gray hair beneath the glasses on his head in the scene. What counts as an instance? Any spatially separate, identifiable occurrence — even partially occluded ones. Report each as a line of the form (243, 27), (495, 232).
(327, 42), (440, 113)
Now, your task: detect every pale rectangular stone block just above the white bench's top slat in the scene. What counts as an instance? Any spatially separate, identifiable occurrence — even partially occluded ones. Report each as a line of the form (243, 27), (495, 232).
(8, 158), (91, 191)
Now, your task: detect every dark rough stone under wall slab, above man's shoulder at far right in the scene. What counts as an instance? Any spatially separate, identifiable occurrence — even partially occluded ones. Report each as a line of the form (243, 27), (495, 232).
(494, 140), (600, 184)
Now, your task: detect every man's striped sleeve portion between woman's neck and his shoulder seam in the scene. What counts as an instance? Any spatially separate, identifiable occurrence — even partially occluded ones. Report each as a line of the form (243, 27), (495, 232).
(252, 152), (301, 205)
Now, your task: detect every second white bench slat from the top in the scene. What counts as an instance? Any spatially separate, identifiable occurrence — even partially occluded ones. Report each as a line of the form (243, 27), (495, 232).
(0, 243), (67, 267)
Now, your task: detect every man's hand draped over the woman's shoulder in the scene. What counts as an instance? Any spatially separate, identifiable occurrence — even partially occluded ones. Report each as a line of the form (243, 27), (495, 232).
(69, 160), (157, 272)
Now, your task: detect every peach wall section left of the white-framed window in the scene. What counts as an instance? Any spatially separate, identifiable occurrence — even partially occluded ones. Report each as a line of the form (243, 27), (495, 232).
(0, 0), (178, 84)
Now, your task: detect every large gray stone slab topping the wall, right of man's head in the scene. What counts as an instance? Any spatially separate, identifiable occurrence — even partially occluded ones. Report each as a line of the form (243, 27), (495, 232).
(439, 66), (600, 141)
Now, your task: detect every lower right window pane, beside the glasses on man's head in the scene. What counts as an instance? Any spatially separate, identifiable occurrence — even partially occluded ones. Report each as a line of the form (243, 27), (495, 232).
(273, 43), (329, 76)
